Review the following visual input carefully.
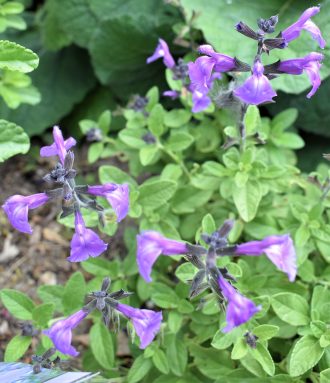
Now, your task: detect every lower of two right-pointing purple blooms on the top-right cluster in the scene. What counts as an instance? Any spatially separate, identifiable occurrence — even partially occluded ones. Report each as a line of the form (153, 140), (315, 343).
(278, 52), (324, 98)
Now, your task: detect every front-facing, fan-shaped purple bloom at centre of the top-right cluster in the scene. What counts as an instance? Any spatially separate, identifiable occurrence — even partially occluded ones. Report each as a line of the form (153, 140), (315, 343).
(234, 60), (276, 105)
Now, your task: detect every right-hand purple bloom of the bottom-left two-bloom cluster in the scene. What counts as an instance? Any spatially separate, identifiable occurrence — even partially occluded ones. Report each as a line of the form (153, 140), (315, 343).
(116, 303), (163, 350)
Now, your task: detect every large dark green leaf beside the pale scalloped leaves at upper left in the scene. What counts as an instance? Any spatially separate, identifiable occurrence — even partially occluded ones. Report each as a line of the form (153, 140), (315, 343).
(0, 47), (95, 136)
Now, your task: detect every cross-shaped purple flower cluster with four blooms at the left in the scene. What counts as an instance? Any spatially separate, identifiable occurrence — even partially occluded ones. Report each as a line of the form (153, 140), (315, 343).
(2, 126), (129, 262)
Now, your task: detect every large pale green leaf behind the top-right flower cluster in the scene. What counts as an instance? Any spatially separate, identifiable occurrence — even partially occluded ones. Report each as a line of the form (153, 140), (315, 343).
(181, 0), (330, 93)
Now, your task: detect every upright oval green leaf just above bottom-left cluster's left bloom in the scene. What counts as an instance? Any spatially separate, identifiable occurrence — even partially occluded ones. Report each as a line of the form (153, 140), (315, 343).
(63, 271), (86, 314)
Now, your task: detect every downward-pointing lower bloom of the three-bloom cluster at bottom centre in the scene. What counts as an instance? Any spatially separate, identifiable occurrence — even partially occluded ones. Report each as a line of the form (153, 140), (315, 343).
(218, 276), (261, 332)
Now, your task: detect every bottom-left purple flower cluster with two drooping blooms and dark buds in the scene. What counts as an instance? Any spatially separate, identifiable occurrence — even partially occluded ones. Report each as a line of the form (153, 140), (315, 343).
(43, 278), (163, 356)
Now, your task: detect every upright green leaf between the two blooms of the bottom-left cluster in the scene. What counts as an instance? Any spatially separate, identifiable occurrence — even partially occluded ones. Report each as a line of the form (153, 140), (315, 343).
(90, 323), (115, 370)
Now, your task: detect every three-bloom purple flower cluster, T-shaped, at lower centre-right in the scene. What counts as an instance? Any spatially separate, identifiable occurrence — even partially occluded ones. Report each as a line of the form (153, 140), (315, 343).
(137, 221), (297, 332)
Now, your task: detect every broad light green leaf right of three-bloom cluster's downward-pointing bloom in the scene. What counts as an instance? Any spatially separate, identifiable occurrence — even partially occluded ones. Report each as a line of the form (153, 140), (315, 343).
(271, 293), (310, 326)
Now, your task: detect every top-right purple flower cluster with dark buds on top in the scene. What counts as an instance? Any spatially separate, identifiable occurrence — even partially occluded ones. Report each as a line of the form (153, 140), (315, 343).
(189, 7), (325, 108)
